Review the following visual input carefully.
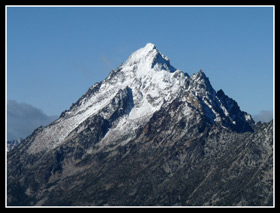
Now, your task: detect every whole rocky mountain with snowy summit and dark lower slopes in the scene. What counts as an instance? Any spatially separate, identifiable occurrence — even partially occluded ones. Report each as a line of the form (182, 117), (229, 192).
(7, 43), (273, 206)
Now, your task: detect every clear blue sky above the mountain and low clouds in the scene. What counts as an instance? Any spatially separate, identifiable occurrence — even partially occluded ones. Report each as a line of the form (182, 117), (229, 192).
(7, 7), (273, 118)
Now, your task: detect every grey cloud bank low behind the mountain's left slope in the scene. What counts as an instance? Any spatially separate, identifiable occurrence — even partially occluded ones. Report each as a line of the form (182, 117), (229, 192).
(7, 100), (58, 140)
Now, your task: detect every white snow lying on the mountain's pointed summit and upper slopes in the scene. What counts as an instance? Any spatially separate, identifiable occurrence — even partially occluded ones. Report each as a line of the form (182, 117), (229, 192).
(28, 43), (255, 153)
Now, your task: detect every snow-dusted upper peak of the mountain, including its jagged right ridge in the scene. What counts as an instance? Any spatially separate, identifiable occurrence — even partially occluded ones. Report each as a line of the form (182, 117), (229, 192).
(26, 43), (254, 153)
